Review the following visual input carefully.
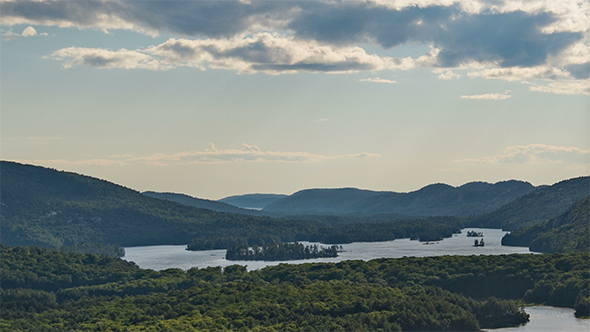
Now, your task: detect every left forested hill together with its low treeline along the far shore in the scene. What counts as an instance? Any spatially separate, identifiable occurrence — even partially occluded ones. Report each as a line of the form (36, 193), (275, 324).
(0, 162), (460, 249)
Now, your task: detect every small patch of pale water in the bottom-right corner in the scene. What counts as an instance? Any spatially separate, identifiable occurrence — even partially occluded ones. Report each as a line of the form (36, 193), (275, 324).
(489, 306), (590, 332)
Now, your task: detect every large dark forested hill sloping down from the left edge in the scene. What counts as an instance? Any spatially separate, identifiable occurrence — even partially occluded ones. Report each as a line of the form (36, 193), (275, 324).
(0, 161), (300, 247)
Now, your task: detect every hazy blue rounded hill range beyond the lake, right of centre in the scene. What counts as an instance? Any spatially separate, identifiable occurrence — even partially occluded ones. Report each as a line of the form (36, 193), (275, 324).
(263, 180), (536, 217)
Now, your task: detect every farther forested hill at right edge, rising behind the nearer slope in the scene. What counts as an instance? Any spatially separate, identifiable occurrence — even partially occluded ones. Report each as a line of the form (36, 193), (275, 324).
(471, 176), (590, 231)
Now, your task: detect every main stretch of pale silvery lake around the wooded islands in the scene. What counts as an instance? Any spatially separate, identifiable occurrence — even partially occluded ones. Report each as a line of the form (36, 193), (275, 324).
(125, 228), (530, 270)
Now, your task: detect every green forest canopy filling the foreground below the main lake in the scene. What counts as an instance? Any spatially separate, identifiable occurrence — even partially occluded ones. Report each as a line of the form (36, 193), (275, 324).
(0, 245), (590, 331)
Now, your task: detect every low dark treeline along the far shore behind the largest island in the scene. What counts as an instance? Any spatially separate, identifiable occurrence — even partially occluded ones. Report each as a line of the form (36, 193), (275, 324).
(187, 217), (463, 250)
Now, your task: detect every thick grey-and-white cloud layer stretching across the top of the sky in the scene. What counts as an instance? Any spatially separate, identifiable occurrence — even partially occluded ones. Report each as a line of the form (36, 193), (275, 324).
(1, 0), (590, 94)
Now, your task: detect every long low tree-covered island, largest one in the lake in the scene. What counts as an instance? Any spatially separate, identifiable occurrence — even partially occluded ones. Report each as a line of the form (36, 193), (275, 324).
(225, 242), (343, 261)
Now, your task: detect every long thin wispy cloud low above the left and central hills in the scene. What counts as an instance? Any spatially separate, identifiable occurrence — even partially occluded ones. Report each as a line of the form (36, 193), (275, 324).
(26, 143), (381, 166)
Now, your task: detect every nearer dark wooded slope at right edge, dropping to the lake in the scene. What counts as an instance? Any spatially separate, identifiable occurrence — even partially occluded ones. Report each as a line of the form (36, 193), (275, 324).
(502, 196), (590, 252)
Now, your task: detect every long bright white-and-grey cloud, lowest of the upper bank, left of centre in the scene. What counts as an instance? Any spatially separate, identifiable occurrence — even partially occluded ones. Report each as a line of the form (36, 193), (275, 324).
(51, 33), (414, 74)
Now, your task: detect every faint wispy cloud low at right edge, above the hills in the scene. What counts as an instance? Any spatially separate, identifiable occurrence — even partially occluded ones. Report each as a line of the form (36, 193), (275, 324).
(457, 144), (590, 164)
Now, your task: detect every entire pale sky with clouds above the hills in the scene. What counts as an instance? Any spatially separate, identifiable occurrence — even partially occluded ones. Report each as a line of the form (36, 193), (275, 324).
(0, 0), (590, 199)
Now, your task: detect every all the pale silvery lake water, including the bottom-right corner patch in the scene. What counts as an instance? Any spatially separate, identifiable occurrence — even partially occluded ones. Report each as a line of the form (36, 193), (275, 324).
(124, 228), (590, 332)
